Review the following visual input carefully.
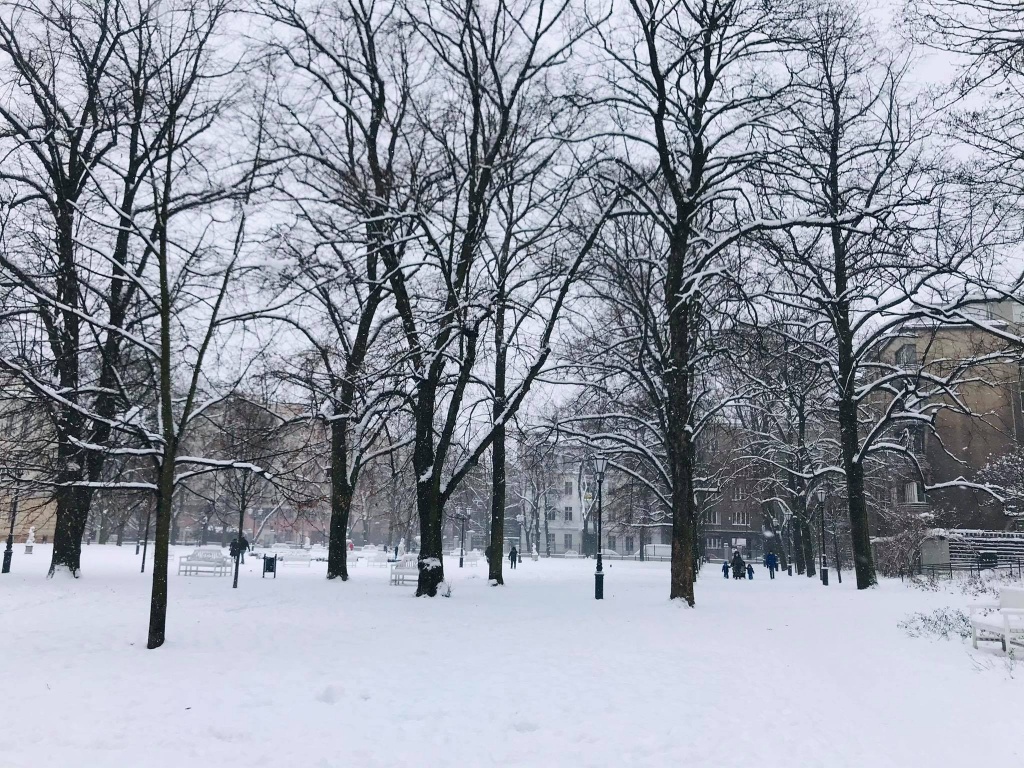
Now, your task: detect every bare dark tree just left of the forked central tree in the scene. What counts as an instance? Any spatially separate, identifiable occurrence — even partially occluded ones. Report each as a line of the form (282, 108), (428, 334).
(257, 0), (429, 581)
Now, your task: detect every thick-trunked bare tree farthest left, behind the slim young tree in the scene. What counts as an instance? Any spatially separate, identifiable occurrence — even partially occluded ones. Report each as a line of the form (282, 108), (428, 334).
(0, 0), (167, 575)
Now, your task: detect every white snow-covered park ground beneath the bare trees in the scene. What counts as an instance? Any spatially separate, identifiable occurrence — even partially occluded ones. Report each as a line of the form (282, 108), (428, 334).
(0, 546), (1024, 768)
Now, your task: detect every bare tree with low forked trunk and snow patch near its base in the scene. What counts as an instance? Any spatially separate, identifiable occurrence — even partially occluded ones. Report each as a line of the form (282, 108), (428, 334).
(385, 0), (601, 596)
